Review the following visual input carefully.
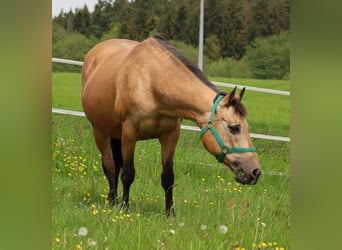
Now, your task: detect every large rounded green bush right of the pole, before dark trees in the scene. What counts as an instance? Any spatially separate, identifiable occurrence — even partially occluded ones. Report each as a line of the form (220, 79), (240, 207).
(246, 32), (290, 79)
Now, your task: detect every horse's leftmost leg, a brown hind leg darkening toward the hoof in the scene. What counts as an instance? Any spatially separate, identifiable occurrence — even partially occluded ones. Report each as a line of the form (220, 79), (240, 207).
(94, 129), (120, 205)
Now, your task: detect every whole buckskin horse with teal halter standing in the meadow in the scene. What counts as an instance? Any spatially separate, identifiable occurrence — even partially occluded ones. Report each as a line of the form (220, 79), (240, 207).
(81, 34), (261, 216)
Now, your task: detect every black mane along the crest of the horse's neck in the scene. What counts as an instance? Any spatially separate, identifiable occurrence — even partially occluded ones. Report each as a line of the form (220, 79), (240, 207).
(153, 34), (222, 95)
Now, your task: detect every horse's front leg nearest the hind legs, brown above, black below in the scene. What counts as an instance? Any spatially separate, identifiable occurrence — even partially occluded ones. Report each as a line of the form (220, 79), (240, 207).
(121, 124), (137, 209)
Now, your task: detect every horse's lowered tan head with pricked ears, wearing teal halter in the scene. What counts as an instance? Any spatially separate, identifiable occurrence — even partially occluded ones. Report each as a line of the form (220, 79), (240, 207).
(201, 87), (261, 185)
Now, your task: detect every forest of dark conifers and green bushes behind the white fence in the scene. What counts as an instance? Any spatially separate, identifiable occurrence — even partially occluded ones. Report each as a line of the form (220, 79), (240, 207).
(52, 0), (290, 79)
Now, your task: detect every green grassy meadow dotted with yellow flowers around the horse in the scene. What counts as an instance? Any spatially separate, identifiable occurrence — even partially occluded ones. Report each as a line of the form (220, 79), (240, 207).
(51, 73), (290, 250)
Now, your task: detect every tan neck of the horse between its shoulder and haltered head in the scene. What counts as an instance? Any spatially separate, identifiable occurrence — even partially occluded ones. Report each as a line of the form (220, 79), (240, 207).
(136, 39), (217, 127)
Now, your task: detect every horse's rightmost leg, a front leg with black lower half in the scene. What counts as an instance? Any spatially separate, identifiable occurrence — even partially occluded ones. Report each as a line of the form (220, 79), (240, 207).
(159, 127), (180, 217)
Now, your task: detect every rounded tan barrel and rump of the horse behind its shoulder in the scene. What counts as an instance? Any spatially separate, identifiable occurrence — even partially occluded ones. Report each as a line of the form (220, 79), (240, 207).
(82, 39), (139, 137)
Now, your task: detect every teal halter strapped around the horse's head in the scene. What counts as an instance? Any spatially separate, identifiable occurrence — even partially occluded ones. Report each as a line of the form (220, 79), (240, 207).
(200, 95), (256, 162)
